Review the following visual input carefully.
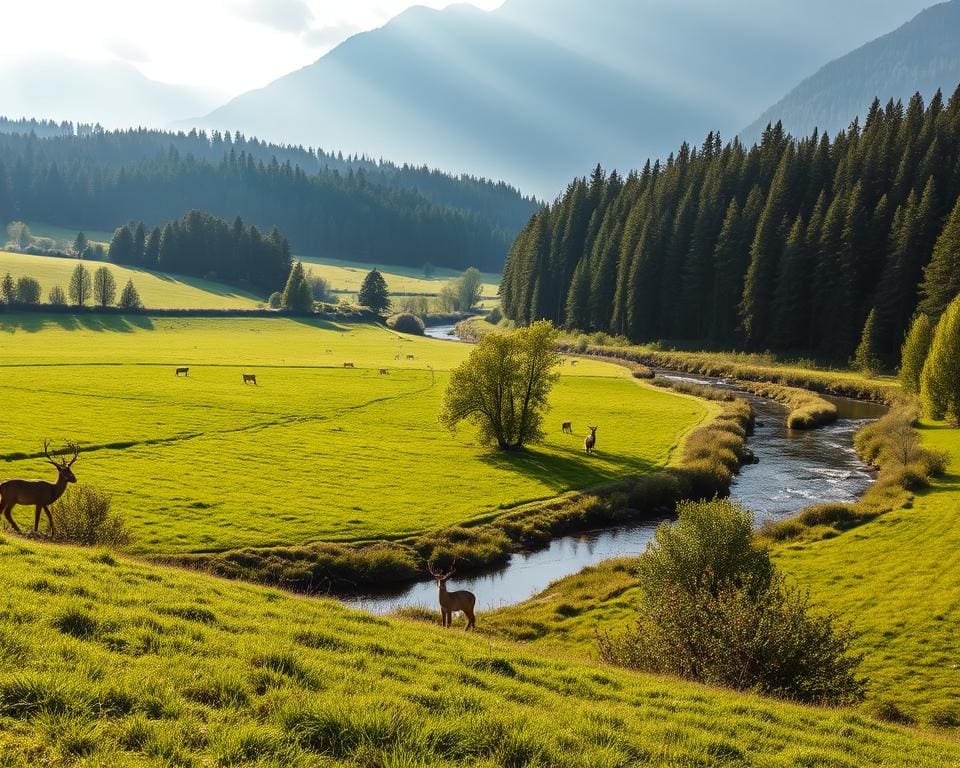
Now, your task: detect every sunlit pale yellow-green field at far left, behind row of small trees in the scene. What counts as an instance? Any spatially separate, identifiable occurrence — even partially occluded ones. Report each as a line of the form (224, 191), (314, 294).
(0, 251), (258, 309)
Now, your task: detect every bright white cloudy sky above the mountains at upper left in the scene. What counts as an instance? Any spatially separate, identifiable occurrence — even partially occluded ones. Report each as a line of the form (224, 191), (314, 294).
(0, 0), (503, 97)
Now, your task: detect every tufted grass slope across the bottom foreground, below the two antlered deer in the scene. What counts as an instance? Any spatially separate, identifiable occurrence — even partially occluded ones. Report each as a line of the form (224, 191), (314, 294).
(0, 537), (960, 768)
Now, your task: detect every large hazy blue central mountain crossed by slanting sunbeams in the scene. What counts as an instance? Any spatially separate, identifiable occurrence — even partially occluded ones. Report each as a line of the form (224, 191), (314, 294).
(191, 0), (925, 199)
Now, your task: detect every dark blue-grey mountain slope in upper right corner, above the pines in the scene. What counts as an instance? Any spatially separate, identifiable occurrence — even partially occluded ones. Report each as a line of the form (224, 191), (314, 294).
(740, 0), (960, 142)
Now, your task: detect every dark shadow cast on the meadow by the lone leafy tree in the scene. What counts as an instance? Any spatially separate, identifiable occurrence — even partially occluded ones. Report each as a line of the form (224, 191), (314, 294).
(480, 438), (660, 490)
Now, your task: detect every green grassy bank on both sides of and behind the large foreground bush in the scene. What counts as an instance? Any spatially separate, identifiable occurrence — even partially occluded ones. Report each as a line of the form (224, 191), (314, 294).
(485, 424), (960, 727)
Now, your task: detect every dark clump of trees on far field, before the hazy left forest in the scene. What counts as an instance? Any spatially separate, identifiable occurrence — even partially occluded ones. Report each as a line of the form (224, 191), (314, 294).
(106, 210), (291, 296)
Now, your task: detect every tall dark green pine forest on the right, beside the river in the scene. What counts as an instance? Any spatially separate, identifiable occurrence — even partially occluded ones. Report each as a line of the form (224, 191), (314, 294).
(501, 89), (960, 361)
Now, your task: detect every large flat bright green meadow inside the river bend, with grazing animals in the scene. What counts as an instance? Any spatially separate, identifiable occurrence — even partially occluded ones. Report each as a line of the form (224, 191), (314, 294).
(0, 314), (709, 553)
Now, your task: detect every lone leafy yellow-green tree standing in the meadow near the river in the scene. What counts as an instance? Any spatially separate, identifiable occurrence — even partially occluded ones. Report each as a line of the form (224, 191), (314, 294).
(440, 321), (561, 450)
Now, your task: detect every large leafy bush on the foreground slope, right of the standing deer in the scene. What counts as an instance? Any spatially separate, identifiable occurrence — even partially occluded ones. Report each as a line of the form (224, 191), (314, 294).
(598, 500), (865, 704)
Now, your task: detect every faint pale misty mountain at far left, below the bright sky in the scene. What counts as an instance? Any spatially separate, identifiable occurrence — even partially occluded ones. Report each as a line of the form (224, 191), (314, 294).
(0, 58), (216, 128)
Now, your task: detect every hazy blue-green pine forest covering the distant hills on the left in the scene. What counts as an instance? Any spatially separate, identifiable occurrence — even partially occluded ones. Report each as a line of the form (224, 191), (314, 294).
(0, 121), (537, 271)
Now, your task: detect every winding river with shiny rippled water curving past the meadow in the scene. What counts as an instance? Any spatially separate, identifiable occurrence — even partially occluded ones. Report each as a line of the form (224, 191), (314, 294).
(346, 326), (886, 613)
